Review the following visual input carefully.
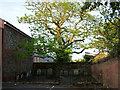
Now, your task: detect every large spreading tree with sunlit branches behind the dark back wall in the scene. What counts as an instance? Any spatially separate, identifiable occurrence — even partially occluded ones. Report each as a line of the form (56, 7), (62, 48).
(19, 1), (94, 62)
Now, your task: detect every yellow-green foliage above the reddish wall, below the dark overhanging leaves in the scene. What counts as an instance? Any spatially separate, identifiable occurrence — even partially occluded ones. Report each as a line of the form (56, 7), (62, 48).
(91, 19), (120, 56)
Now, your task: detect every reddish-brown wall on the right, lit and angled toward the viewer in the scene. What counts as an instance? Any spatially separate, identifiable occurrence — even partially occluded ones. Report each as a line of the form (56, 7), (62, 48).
(91, 58), (120, 88)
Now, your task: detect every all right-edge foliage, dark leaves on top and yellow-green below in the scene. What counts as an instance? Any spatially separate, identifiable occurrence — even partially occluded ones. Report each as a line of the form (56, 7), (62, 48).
(91, 2), (120, 56)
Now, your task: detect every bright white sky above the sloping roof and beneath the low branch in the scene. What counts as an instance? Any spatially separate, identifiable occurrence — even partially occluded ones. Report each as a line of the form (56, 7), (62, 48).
(0, 0), (99, 60)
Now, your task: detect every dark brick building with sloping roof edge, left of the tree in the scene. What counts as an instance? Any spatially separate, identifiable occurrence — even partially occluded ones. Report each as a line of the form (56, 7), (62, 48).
(0, 19), (33, 81)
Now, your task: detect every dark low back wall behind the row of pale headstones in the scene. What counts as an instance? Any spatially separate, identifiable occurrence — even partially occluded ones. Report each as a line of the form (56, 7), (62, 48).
(32, 62), (91, 76)
